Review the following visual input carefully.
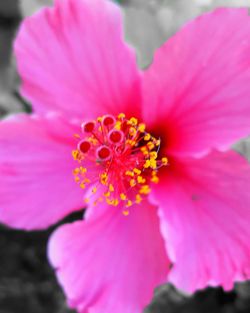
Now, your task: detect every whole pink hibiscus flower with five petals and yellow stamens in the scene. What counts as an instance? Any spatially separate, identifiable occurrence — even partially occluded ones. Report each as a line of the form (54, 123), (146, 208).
(0, 0), (250, 313)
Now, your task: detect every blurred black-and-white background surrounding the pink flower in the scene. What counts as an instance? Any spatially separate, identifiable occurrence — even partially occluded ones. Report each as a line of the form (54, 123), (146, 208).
(0, 0), (250, 313)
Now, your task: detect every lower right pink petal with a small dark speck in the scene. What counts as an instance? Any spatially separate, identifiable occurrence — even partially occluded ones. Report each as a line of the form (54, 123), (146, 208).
(151, 151), (250, 291)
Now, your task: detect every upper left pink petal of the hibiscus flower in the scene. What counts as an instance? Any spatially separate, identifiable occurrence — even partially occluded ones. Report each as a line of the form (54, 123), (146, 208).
(15, 0), (140, 118)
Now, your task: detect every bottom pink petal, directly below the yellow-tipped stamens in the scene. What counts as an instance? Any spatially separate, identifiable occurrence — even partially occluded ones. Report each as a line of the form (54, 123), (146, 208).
(49, 203), (169, 313)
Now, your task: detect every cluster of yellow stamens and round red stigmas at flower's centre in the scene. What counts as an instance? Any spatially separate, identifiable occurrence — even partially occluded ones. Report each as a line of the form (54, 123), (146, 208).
(72, 113), (168, 215)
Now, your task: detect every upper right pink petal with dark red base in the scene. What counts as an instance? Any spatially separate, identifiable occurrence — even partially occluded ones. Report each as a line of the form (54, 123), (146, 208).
(144, 9), (250, 155)
